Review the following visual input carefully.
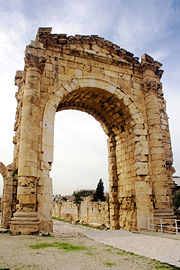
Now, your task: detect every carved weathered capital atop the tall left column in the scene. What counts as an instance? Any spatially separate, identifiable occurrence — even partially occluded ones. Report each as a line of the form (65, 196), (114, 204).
(25, 53), (47, 72)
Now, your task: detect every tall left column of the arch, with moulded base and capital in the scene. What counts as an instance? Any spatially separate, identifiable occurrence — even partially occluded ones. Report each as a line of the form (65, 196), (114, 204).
(10, 54), (45, 234)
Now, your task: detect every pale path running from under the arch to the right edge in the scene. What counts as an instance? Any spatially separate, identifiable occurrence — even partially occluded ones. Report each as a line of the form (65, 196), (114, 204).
(54, 222), (180, 267)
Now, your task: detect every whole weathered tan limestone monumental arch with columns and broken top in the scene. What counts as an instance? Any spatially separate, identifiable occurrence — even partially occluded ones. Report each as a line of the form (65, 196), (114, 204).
(2, 28), (173, 234)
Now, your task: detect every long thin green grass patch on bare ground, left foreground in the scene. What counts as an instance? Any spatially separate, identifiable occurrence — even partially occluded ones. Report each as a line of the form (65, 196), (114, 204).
(29, 242), (88, 251)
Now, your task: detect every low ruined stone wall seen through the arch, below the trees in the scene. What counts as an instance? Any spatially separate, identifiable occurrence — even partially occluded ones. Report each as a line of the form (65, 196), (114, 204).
(53, 197), (110, 228)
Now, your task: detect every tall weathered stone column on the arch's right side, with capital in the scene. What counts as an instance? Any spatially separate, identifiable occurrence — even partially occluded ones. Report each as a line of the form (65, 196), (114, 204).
(142, 55), (172, 216)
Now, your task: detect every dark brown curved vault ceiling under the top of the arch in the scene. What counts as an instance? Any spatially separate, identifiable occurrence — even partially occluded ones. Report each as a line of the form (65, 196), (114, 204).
(56, 88), (130, 137)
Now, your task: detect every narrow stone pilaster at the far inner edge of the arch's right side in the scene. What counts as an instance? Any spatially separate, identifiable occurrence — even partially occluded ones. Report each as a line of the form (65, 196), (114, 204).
(108, 138), (119, 230)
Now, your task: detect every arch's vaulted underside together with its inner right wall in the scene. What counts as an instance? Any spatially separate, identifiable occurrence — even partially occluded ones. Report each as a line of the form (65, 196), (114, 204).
(56, 87), (137, 229)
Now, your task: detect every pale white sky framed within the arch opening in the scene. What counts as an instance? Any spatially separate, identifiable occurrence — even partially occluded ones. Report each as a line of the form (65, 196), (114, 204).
(50, 109), (109, 195)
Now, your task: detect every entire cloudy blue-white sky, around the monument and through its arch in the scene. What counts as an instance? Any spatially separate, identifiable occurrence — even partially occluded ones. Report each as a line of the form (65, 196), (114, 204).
(0, 0), (180, 194)
